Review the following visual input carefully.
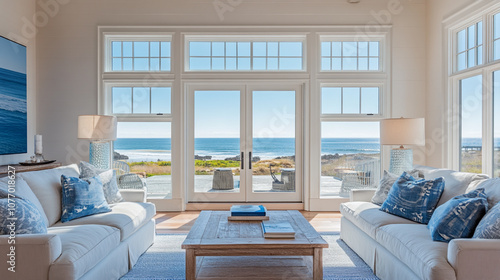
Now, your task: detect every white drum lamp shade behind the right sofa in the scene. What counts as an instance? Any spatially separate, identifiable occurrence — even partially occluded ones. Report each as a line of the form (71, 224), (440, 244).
(380, 118), (425, 146)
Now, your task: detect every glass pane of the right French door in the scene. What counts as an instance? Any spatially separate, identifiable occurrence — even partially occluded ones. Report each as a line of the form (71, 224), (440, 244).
(252, 91), (296, 192)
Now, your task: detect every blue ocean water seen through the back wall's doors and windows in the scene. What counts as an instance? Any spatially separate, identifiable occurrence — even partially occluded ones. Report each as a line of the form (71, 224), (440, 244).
(114, 138), (380, 161)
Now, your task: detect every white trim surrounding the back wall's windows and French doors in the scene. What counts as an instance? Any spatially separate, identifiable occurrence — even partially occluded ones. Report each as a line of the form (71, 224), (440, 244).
(98, 25), (392, 211)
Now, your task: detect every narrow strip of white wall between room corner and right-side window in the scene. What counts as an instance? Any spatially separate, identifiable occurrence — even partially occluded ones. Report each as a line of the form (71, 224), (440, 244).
(426, 0), (480, 167)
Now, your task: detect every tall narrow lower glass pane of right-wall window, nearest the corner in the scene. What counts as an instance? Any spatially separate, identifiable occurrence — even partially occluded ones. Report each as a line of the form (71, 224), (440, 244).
(460, 75), (483, 173)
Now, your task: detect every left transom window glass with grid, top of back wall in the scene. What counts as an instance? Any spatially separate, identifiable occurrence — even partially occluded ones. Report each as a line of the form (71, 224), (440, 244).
(111, 41), (171, 72)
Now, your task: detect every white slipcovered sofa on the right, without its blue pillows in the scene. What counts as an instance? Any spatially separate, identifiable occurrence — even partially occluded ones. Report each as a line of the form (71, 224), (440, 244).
(341, 166), (500, 280)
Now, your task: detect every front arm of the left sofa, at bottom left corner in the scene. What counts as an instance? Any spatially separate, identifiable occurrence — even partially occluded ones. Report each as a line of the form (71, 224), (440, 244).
(0, 234), (62, 279)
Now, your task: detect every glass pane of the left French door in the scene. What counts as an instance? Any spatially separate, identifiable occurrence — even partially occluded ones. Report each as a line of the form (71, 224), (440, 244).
(194, 91), (240, 192)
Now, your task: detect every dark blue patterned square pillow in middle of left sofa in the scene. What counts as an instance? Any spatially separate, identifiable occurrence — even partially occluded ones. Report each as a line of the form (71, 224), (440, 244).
(61, 175), (111, 223)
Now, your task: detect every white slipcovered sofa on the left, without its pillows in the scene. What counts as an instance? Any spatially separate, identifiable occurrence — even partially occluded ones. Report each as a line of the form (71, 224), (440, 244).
(0, 164), (156, 280)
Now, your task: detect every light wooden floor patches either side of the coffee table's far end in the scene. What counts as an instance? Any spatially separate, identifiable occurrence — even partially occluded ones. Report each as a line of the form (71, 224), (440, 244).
(155, 211), (342, 234)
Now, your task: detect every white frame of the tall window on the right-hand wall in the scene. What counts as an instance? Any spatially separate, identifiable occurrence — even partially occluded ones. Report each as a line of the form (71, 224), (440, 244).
(443, 2), (500, 176)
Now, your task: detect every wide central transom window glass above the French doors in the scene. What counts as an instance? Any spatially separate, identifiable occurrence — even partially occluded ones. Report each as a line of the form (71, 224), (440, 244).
(188, 39), (304, 71)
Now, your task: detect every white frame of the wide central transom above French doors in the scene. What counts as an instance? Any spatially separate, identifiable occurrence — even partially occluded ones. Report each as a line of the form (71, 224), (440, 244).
(183, 33), (307, 73)
